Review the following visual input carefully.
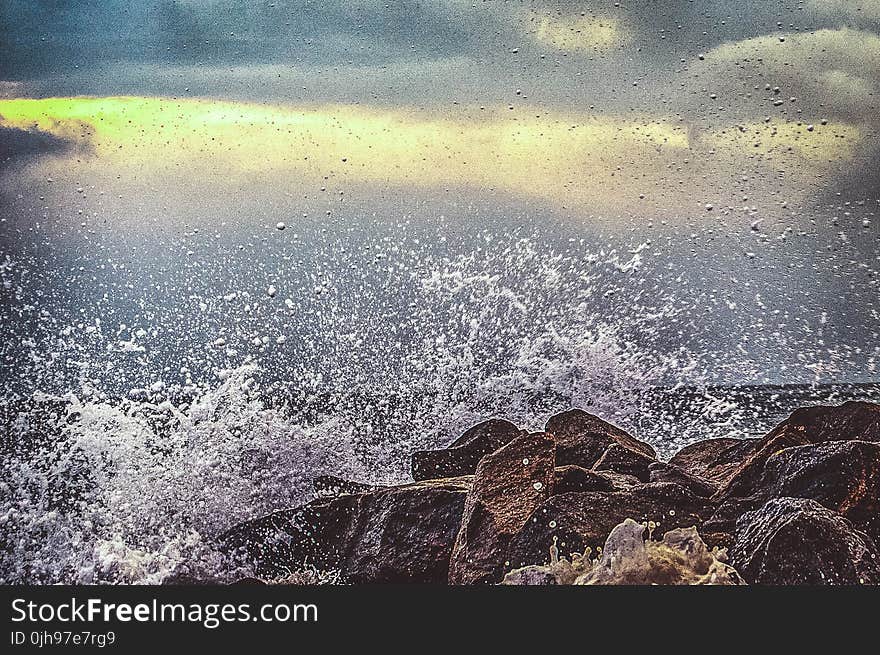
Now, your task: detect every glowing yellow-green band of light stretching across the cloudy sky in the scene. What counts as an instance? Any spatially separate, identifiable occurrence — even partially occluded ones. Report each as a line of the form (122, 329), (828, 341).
(0, 97), (860, 218)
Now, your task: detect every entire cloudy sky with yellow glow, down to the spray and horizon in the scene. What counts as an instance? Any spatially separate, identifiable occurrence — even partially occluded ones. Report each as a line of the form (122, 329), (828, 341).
(0, 0), (880, 394)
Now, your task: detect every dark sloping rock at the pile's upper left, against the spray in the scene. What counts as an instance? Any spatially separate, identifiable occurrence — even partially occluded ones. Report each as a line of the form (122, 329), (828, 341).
(412, 419), (524, 481)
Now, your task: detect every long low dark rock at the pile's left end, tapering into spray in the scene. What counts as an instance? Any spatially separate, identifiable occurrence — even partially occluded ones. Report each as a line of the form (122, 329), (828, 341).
(218, 478), (469, 583)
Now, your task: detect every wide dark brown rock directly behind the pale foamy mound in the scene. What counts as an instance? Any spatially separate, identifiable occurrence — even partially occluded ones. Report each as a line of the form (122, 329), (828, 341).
(507, 482), (713, 568)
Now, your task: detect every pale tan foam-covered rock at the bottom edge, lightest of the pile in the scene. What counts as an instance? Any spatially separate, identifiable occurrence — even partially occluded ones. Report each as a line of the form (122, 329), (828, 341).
(502, 519), (743, 585)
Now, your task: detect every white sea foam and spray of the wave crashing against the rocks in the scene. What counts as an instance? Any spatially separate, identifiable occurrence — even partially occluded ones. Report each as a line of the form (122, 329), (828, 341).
(0, 240), (876, 583)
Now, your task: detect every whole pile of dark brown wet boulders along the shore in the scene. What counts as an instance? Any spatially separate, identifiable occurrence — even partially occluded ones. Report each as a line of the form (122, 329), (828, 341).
(173, 402), (880, 585)
